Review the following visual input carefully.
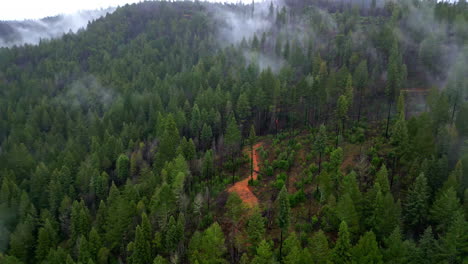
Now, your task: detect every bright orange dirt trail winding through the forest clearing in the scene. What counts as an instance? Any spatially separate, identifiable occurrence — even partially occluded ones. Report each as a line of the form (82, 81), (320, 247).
(228, 143), (262, 207)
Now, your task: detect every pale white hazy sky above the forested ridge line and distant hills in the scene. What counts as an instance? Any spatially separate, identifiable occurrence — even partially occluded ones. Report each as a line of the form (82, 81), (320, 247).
(0, 0), (252, 20)
